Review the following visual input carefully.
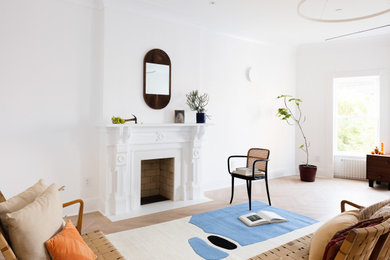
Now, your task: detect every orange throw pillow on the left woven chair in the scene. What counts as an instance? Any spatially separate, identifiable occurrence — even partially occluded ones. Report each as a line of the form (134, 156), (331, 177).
(45, 220), (97, 260)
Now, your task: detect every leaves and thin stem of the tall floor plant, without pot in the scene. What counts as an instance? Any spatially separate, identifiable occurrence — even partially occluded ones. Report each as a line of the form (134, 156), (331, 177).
(277, 95), (310, 165)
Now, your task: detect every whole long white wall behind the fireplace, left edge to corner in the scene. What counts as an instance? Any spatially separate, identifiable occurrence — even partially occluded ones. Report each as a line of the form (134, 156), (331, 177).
(0, 0), (295, 213)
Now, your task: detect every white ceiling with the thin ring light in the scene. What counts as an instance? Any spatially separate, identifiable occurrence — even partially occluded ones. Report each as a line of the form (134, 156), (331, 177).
(127, 0), (390, 45)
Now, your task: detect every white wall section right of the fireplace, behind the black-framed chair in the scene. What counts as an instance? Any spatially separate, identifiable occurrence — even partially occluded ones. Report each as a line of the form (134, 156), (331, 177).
(198, 32), (295, 189)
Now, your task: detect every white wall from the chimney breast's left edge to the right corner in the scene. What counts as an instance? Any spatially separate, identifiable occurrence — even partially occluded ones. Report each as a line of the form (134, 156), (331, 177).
(103, 3), (295, 189)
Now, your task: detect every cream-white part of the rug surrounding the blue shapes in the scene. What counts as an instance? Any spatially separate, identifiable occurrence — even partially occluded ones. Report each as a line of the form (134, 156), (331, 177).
(107, 217), (322, 260)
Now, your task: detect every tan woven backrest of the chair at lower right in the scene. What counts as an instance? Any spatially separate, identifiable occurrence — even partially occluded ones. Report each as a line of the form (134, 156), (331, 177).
(335, 219), (390, 260)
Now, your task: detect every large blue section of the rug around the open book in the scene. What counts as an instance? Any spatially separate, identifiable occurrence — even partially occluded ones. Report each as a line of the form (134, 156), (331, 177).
(190, 201), (318, 246)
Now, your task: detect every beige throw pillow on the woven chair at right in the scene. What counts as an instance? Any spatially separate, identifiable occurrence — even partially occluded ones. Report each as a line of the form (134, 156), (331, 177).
(309, 210), (359, 260)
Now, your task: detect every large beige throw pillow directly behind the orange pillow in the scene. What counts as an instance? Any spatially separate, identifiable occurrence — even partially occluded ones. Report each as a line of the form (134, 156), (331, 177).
(7, 184), (62, 260)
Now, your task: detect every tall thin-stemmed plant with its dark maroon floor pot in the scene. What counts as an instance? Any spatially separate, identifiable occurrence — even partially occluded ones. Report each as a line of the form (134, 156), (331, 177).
(277, 95), (317, 182)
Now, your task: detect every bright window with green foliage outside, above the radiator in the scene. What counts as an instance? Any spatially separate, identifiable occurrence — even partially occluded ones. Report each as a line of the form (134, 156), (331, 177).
(333, 76), (380, 155)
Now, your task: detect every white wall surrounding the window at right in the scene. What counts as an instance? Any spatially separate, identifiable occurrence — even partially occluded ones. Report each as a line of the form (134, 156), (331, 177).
(296, 35), (390, 177)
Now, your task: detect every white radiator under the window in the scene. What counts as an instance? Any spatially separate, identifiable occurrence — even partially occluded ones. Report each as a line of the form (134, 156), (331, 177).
(334, 156), (366, 180)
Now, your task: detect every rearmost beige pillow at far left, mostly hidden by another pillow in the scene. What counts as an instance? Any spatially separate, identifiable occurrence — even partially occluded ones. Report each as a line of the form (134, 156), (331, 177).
(0, 179), (47, 234)
